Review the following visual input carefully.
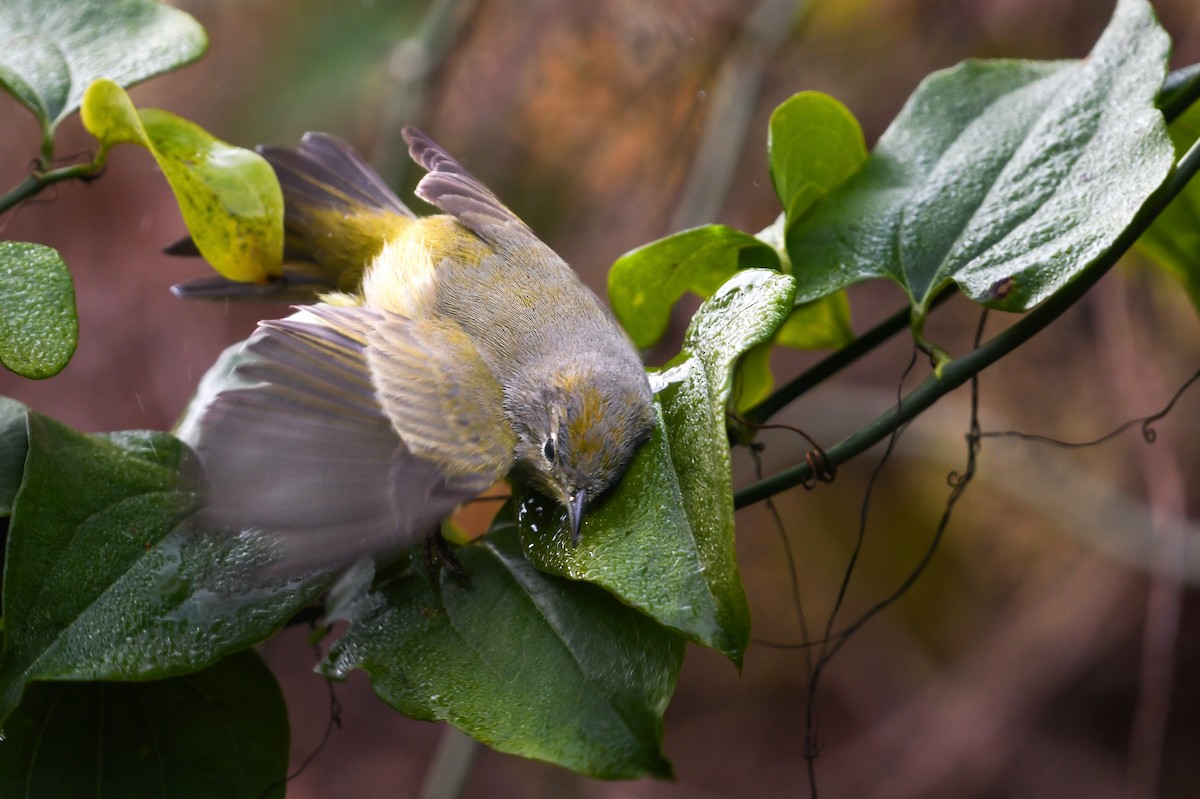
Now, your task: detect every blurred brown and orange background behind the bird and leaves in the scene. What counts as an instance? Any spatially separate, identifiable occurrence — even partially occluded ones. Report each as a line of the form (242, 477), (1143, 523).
(0, 0), (1200, 799)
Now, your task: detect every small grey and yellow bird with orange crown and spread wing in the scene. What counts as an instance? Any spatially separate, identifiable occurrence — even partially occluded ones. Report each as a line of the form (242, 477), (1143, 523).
(189, 127), (655, 570)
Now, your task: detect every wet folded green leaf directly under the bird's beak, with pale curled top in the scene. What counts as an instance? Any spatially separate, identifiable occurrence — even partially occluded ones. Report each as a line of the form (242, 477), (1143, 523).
(517, 269), (796, 665)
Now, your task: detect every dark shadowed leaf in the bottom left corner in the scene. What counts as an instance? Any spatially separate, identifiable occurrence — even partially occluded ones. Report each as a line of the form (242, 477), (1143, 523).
(0, 651), (289, 799)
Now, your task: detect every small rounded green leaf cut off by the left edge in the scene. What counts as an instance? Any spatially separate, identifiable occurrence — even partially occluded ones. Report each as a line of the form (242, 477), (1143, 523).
(0, 241), (79, 379)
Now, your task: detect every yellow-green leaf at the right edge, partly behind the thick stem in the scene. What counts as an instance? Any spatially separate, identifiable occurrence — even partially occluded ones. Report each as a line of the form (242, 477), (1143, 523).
(1138, 97), (1200, 311)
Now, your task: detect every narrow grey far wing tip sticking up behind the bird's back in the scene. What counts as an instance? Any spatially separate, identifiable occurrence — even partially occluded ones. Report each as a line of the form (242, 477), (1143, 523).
(403, 126), (536, 244)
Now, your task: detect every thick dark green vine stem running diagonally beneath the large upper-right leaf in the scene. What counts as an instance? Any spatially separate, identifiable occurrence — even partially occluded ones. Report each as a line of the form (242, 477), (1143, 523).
(733, 130), (1200, 507)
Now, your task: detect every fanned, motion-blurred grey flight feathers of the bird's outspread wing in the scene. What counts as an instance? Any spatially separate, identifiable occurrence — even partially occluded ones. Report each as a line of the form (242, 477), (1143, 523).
(196, 306), (498, 575)
